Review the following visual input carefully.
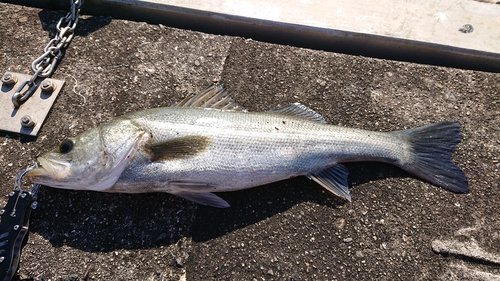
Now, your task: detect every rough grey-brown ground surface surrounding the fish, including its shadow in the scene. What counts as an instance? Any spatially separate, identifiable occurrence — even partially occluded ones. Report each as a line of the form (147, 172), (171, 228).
(0, 4), (500, 280)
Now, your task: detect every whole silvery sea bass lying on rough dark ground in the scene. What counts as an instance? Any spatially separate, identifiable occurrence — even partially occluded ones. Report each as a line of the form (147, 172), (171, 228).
(27, 86), (468, 208)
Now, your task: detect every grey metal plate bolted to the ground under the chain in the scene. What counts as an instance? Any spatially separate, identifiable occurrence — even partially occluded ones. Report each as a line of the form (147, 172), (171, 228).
(0, 72), (64, 136)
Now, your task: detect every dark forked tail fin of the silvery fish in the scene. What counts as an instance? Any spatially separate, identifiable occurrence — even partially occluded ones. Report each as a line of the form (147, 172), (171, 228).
(394, 121), (469, 193)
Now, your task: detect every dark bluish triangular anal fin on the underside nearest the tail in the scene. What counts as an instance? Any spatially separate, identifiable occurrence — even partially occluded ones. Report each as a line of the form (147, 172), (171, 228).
(309, 164), (351, 202)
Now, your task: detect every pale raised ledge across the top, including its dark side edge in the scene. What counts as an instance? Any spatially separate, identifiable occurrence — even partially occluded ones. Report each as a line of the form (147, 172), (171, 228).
(4, 0), (500, 72)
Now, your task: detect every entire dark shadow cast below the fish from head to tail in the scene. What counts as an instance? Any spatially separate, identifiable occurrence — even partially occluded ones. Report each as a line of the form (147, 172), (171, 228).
(31, 163), (408, 252)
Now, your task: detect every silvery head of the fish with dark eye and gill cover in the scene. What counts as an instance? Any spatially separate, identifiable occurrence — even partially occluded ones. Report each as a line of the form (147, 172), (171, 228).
(26, 118), (144, 191)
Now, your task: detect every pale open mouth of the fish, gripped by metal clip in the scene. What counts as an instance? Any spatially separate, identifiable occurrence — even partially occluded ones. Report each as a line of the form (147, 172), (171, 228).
(26, 154), (71, 185)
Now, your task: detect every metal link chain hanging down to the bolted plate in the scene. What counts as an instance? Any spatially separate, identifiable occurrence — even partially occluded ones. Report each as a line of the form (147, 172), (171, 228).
(12, 0), (84, 108)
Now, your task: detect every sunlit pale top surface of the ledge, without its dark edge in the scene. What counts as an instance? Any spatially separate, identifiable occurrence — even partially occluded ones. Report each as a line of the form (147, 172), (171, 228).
(86, 0), (500, 53)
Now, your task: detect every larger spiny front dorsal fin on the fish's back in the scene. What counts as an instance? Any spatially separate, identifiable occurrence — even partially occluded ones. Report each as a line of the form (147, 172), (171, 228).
(173, 85), (245, 111)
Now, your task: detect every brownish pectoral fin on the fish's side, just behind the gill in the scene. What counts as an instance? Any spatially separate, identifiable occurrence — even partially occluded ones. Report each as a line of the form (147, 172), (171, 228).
(146, 136), (210, 162)
